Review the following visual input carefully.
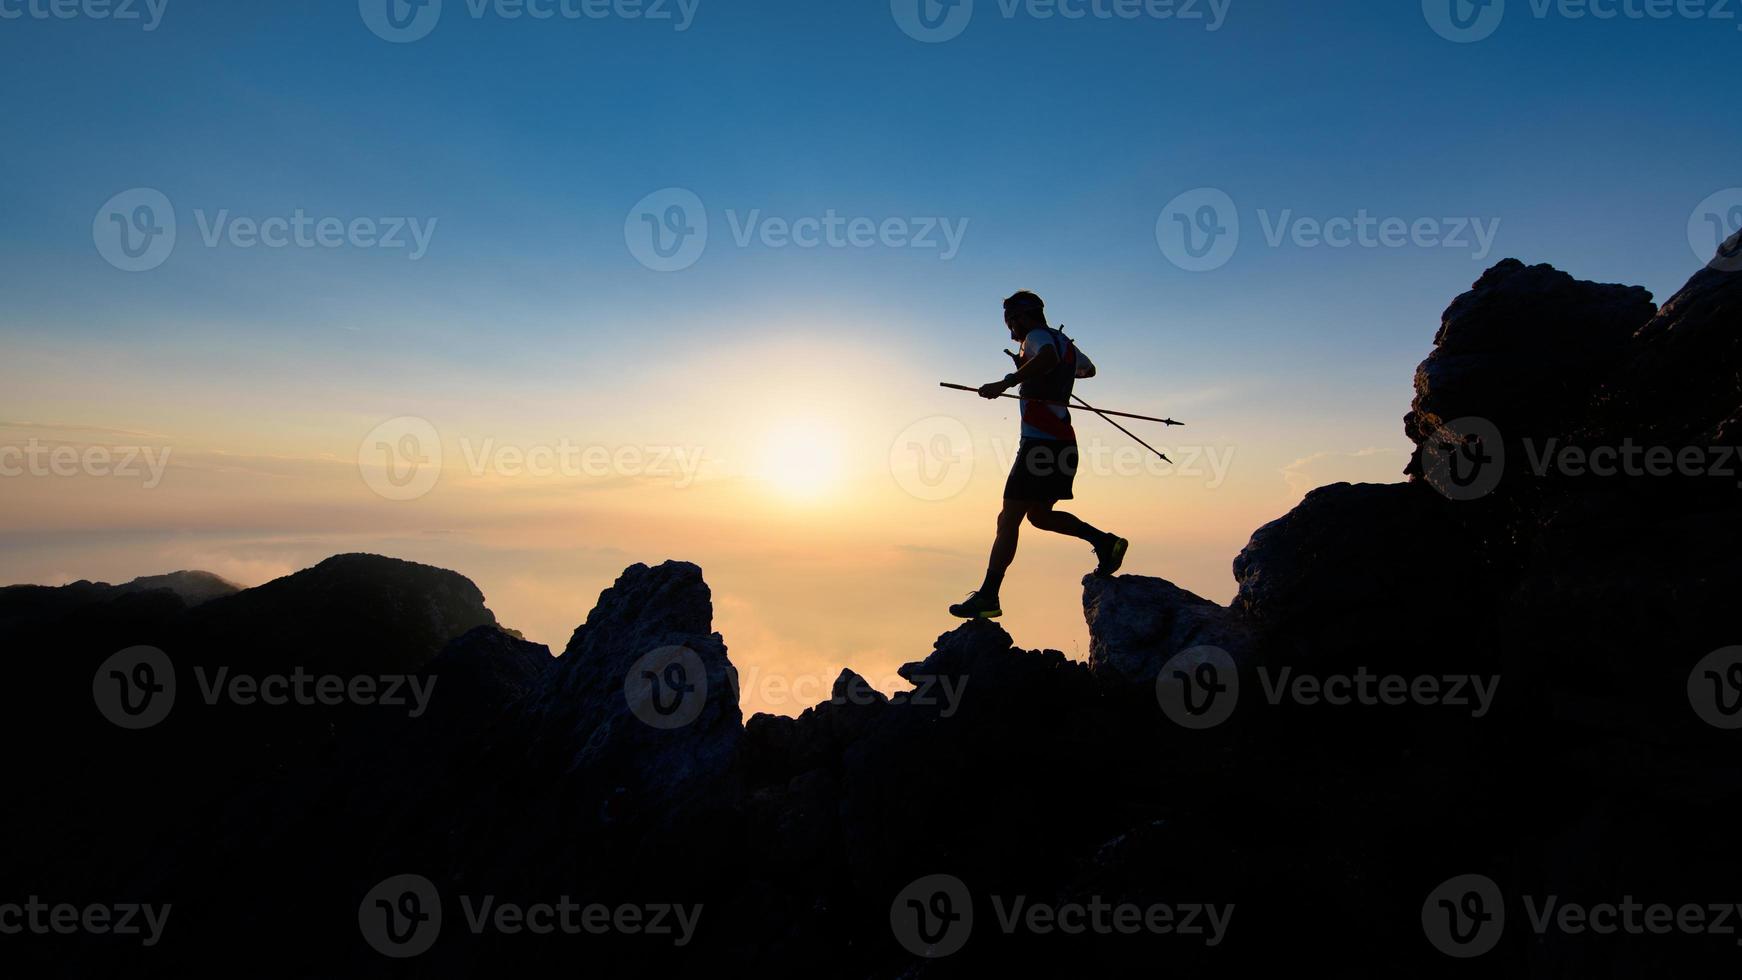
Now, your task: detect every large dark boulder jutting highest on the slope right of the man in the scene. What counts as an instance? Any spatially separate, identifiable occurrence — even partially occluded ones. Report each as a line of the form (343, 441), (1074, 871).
(1404, 259), (1657, 475)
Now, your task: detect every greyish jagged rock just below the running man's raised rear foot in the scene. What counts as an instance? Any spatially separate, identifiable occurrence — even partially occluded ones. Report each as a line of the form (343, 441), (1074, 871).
(1084, 574), (1252, 682)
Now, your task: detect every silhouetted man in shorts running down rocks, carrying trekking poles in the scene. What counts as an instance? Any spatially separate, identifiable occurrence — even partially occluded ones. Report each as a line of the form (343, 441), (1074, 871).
(949, 289), (1131, 620)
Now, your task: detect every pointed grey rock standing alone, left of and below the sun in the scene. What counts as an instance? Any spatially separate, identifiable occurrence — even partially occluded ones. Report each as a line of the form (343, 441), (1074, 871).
(535, 560), (744, 802)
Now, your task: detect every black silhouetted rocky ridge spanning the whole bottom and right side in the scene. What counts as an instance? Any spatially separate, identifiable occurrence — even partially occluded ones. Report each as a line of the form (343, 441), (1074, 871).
(0, 243), (1742, 977)
